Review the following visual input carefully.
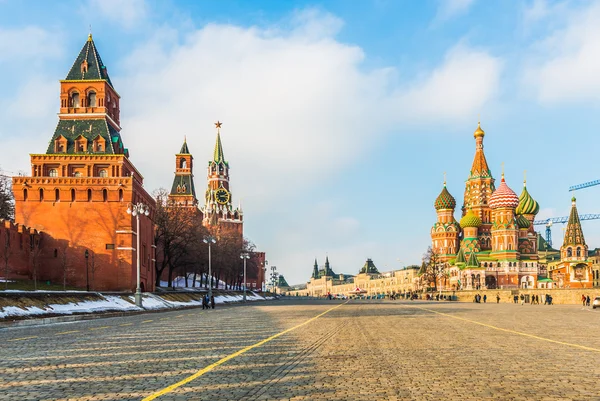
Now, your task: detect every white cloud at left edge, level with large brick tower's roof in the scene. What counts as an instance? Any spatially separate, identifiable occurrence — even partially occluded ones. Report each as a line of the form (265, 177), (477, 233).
(0, 26), (63, 64)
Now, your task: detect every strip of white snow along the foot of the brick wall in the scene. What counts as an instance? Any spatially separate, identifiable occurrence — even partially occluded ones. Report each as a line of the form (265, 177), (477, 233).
(0, 291), (272, 319)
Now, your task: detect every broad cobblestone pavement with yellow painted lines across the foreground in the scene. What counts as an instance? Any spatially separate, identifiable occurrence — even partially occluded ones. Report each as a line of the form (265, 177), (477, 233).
(0, 300), (600, 401)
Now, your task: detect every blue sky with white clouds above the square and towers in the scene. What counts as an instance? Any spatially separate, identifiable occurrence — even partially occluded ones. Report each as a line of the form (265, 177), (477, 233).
(0, 0), (600, 284)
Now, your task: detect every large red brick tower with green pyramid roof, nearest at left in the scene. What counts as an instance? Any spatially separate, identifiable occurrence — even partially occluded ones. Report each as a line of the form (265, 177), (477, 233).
(13, 34), (155, 290)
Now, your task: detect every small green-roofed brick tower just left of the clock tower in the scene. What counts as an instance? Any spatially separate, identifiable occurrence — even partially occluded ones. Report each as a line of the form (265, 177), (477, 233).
(169, 139), (198, 208)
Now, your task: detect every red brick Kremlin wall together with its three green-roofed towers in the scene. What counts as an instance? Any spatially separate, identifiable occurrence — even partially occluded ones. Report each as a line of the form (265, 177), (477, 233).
(0, 34), (265, 291)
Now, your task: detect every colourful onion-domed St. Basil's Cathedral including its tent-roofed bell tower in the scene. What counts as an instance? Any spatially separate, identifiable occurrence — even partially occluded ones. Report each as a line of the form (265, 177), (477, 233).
(431, 124), (592, 290)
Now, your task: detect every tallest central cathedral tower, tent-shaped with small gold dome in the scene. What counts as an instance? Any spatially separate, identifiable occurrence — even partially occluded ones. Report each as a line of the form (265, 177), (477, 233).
(462, 123), (496, 250)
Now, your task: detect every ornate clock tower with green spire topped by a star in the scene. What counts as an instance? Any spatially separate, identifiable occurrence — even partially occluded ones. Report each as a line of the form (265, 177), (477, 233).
(202, 121), (244, 235)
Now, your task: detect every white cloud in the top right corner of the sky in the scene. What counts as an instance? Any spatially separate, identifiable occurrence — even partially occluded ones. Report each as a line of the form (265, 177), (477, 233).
(523, 2), (600, 104)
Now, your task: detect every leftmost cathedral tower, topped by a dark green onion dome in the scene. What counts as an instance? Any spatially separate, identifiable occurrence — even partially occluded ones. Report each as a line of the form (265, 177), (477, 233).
(431, 180), (460, 262)
